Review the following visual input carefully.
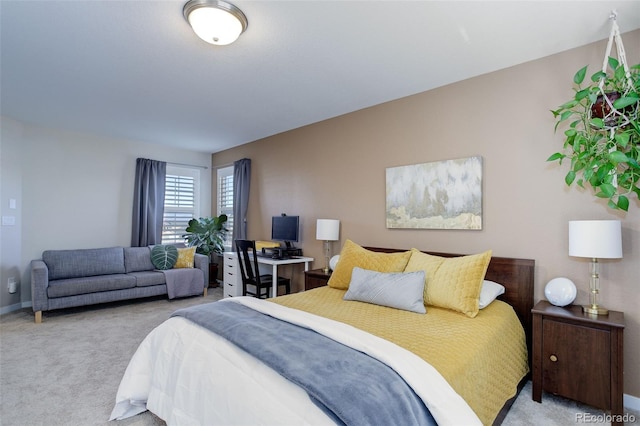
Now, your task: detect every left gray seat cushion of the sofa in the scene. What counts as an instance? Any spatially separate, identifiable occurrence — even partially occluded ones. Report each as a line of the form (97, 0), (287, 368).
(47, 274), (136, 298)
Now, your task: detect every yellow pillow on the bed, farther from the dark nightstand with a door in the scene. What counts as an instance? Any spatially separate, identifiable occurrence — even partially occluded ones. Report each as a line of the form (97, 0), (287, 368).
(327, 240), (411, 290)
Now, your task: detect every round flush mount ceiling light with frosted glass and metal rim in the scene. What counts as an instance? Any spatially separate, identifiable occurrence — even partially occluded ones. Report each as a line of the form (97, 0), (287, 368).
(182, 0), (249, 46)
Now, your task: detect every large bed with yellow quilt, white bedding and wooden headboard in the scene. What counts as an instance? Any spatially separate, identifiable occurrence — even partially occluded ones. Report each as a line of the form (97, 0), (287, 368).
(111, 241), (534, 425)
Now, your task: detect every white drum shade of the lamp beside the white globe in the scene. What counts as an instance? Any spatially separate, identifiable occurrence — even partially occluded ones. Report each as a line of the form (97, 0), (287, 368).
(569, 220), (622, 259)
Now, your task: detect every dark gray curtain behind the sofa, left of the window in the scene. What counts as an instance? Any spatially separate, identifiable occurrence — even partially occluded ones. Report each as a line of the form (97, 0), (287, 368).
(131, 158), (167, 247)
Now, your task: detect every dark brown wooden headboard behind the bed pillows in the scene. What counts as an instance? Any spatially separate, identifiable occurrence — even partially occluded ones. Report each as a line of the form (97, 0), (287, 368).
(365, 247), (535, 360)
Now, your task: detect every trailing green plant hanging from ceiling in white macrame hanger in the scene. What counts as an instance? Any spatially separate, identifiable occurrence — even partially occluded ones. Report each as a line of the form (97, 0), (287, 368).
(547, 21), (640, 211)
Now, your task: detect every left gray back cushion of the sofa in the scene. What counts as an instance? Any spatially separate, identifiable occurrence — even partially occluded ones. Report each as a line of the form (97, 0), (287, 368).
(42, 247), (125, 280)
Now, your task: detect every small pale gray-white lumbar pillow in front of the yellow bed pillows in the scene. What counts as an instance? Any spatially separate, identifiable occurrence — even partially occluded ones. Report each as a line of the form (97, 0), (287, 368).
(344, 267), (427, 314)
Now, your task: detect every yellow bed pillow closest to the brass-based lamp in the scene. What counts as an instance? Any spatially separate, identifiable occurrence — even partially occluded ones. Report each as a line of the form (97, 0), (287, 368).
(405, 249), (492, 318)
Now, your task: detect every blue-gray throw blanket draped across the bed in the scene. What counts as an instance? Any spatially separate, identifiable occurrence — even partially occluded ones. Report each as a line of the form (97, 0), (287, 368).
(172, 302), (436, 425)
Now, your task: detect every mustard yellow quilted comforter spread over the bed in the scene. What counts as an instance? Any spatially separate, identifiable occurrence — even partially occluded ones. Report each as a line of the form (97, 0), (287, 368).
(270, 287), (528, 425)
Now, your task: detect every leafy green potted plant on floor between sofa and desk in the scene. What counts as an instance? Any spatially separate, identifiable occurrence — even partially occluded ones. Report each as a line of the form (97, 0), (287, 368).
(182, 214), (228, 287)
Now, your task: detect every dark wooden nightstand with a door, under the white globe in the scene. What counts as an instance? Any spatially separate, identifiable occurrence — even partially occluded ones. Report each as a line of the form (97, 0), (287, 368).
(531, 301), (624, 424)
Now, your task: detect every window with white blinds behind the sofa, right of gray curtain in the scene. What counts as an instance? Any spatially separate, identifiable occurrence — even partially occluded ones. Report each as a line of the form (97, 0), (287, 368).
(162, 165), (200, 244)
